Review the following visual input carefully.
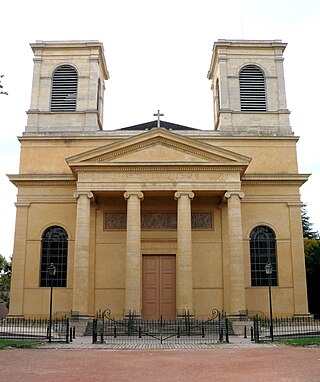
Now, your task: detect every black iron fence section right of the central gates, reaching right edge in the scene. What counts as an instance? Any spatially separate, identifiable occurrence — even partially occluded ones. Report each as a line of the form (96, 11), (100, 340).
(253, 317), (320, 342)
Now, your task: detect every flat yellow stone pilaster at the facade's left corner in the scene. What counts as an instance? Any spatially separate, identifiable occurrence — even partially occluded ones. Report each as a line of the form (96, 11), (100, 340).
(9, 202), (29, 317)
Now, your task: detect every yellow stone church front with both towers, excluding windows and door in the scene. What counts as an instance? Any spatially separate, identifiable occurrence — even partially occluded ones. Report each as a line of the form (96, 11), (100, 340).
(9, 40), (308, 317)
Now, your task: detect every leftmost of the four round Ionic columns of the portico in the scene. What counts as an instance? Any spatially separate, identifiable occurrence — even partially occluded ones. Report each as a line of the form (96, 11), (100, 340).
(72, 191), (93, 317)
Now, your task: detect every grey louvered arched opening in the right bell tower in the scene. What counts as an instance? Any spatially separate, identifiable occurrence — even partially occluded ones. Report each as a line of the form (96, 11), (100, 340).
(239, 65), (267, 111)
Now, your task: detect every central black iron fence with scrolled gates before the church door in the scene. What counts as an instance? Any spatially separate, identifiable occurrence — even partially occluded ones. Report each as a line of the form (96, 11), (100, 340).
(92, 309), (228, 344)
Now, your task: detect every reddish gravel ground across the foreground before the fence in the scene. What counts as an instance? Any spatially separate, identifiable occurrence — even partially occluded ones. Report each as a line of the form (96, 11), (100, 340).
(0, 337), (320, 382)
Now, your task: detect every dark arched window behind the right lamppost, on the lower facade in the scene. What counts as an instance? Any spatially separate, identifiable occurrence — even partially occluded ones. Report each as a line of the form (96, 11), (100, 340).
(250, 225), (278, 286)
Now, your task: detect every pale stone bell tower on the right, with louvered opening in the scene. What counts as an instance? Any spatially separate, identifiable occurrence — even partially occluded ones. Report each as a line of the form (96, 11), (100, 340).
(208, 40), (292, 135)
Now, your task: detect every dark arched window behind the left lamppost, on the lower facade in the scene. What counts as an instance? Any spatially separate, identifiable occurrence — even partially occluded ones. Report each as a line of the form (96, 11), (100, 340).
(40, 226), (68, 287)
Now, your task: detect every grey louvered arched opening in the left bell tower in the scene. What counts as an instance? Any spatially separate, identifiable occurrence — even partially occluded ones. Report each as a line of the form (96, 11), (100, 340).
(50, 65), (78, 111)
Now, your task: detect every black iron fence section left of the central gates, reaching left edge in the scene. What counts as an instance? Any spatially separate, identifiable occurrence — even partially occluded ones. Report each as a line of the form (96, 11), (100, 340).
(0, 318), (73, 342)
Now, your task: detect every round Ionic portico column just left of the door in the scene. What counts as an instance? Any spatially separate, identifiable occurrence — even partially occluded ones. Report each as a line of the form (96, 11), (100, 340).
(124, 191), (143, 314)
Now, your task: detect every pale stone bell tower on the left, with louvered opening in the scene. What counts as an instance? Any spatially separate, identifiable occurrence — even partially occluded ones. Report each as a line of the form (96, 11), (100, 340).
(25, 40), (109, 135)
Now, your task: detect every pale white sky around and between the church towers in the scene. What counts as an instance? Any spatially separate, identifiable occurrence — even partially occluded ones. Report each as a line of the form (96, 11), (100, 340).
(0, 0), (320, 258)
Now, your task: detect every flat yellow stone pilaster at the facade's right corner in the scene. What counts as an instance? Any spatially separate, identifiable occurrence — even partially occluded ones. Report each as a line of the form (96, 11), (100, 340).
(288, 203), (309, 315)
